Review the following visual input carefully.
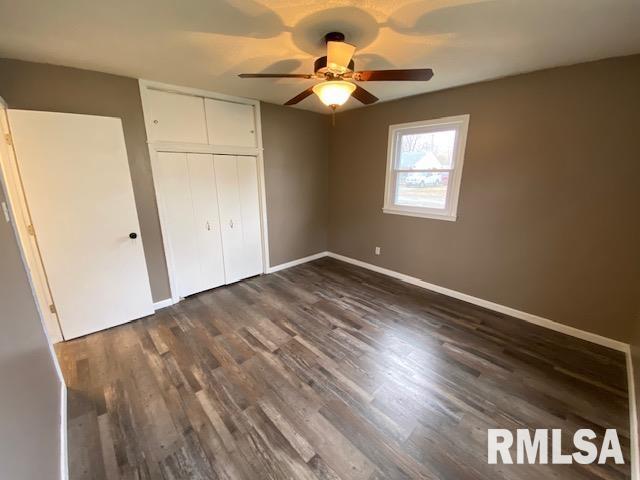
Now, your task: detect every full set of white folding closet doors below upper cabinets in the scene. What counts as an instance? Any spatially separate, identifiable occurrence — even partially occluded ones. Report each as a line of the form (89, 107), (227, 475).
(156, 152), (262, 297)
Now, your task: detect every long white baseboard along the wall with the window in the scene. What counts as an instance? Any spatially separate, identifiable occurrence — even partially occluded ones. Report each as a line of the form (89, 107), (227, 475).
(329, 252), (629, 352)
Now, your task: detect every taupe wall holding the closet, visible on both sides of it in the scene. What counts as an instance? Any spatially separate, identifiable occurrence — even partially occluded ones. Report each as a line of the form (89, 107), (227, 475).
(0, 59), (328, 301)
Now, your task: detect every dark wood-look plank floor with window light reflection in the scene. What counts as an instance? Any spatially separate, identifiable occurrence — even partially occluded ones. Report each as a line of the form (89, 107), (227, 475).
(57, 259), (630, 480)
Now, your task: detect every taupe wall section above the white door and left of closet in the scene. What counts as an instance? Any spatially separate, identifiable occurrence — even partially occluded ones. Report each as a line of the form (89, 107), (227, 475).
(0, 59), (171, 301)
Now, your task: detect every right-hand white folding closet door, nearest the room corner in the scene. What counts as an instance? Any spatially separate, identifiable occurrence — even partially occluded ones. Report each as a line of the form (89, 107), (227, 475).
(214, 155), (262, 283)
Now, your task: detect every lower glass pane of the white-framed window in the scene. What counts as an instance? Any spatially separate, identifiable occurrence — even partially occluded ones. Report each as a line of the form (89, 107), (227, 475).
(394, 172), (451, 209)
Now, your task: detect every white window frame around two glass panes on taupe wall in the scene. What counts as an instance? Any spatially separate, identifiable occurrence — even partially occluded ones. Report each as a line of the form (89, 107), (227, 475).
(382, 115), (469, 222)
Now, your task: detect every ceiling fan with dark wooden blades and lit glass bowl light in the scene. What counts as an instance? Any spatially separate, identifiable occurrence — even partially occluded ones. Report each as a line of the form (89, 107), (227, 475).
(238, 32), (433, 111)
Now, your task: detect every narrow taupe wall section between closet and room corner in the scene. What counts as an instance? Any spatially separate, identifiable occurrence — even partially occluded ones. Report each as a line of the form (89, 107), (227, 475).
(260, 103), (329, 266)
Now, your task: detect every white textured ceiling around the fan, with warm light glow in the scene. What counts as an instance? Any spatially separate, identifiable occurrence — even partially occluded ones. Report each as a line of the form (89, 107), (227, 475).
(0, 0), (640, 111)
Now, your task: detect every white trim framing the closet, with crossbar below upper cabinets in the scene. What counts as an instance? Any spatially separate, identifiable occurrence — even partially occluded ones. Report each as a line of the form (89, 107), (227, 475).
(139, 79), (269, 305)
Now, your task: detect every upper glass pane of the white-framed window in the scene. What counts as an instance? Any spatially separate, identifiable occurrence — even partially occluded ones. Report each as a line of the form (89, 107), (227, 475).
(396, 130), (456, 170)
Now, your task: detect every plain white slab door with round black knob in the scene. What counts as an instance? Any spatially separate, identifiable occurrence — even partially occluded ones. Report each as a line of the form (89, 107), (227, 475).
(8, 110), (153, 339)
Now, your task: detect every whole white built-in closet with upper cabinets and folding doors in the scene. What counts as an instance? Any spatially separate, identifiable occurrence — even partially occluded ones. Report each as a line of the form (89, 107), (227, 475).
(140, 81), (266, 302)
